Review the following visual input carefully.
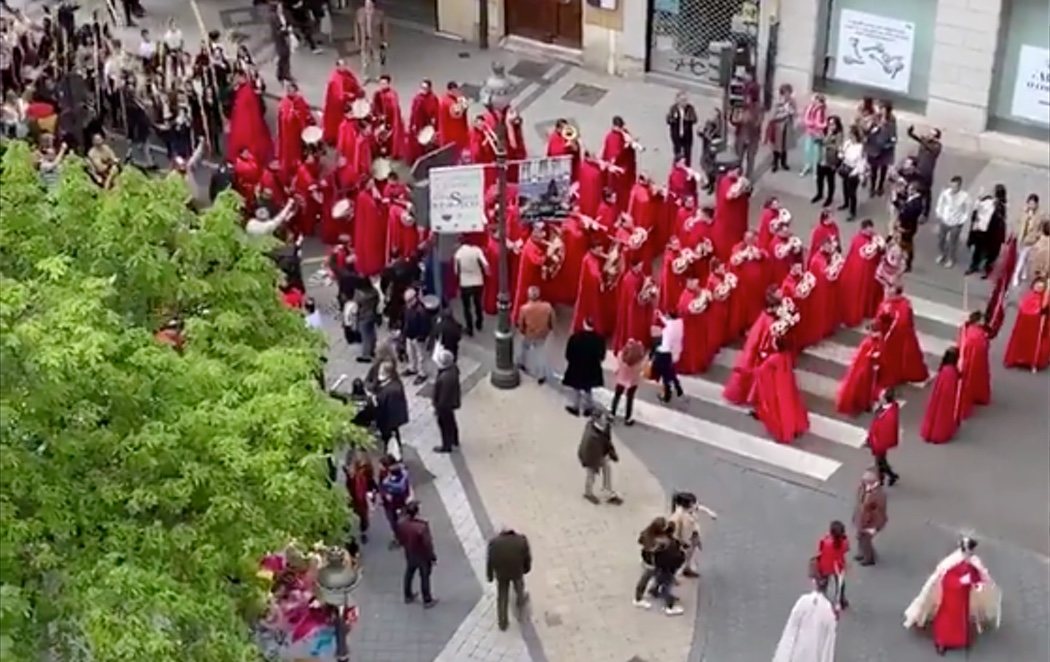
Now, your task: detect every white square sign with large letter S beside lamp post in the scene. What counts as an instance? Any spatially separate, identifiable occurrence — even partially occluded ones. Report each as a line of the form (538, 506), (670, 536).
(429, 166), (485, 234)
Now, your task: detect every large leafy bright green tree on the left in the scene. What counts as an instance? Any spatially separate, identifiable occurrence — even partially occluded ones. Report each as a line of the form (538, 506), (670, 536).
(0, 144), (363, 662)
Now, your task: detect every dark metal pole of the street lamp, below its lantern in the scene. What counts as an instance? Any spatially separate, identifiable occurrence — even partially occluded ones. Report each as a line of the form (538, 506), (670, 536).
(490, 114), (521, 389)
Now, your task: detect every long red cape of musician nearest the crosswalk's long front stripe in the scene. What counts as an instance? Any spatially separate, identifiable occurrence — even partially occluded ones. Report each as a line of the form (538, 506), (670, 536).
(749, 352), (810, 443)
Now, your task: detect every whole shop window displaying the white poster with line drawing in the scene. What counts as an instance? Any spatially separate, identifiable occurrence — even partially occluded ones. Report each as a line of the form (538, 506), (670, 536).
(814, 0), (937, 112)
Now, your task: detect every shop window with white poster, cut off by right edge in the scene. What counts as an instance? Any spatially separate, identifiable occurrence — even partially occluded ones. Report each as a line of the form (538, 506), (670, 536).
(988, 0), (1050, 141)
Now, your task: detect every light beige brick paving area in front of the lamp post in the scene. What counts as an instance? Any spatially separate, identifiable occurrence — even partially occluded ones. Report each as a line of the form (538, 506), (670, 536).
(460, 381), (696, 662)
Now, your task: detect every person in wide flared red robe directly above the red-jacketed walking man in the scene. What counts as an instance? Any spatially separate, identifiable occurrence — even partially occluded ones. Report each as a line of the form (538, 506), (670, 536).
(876, 286), (929, 389)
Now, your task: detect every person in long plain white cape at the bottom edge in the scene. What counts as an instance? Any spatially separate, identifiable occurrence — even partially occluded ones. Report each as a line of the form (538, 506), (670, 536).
(773, 579), (839, 662)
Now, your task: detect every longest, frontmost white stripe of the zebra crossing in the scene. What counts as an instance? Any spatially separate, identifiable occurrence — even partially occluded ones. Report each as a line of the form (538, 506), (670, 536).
(594, 389), (842, 481)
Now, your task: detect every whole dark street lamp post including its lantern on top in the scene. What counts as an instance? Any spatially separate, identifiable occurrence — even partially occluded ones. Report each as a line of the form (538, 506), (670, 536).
(482, 63), (521, 389)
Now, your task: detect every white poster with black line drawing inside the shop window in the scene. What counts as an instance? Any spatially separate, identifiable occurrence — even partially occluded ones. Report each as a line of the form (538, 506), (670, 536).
(835, 9), (916, 94)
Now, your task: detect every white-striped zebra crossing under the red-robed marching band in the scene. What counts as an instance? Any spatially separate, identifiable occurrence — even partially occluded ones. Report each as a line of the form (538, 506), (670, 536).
(594, 296), (966, 482)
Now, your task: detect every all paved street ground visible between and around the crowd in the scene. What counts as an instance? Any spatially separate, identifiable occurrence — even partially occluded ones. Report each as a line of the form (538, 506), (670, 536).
(14, 0), (1050, 662)
